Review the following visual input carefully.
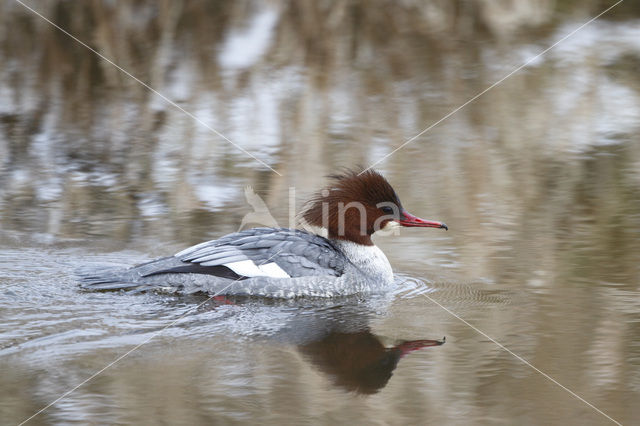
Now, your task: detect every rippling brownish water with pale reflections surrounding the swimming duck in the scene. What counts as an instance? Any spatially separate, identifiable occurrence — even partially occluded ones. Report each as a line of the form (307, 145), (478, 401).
(0, 0), (640, 425)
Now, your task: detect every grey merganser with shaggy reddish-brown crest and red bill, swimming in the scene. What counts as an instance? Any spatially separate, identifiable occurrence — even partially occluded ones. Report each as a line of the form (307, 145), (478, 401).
(81, 170), (448, 298)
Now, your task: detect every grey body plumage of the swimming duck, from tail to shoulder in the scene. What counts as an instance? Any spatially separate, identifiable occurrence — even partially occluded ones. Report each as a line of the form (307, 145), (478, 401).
(80, 228), (354, 297)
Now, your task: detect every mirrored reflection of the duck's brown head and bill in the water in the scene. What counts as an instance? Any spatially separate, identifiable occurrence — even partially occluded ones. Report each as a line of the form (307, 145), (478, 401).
(206, 298), (445, 394)
